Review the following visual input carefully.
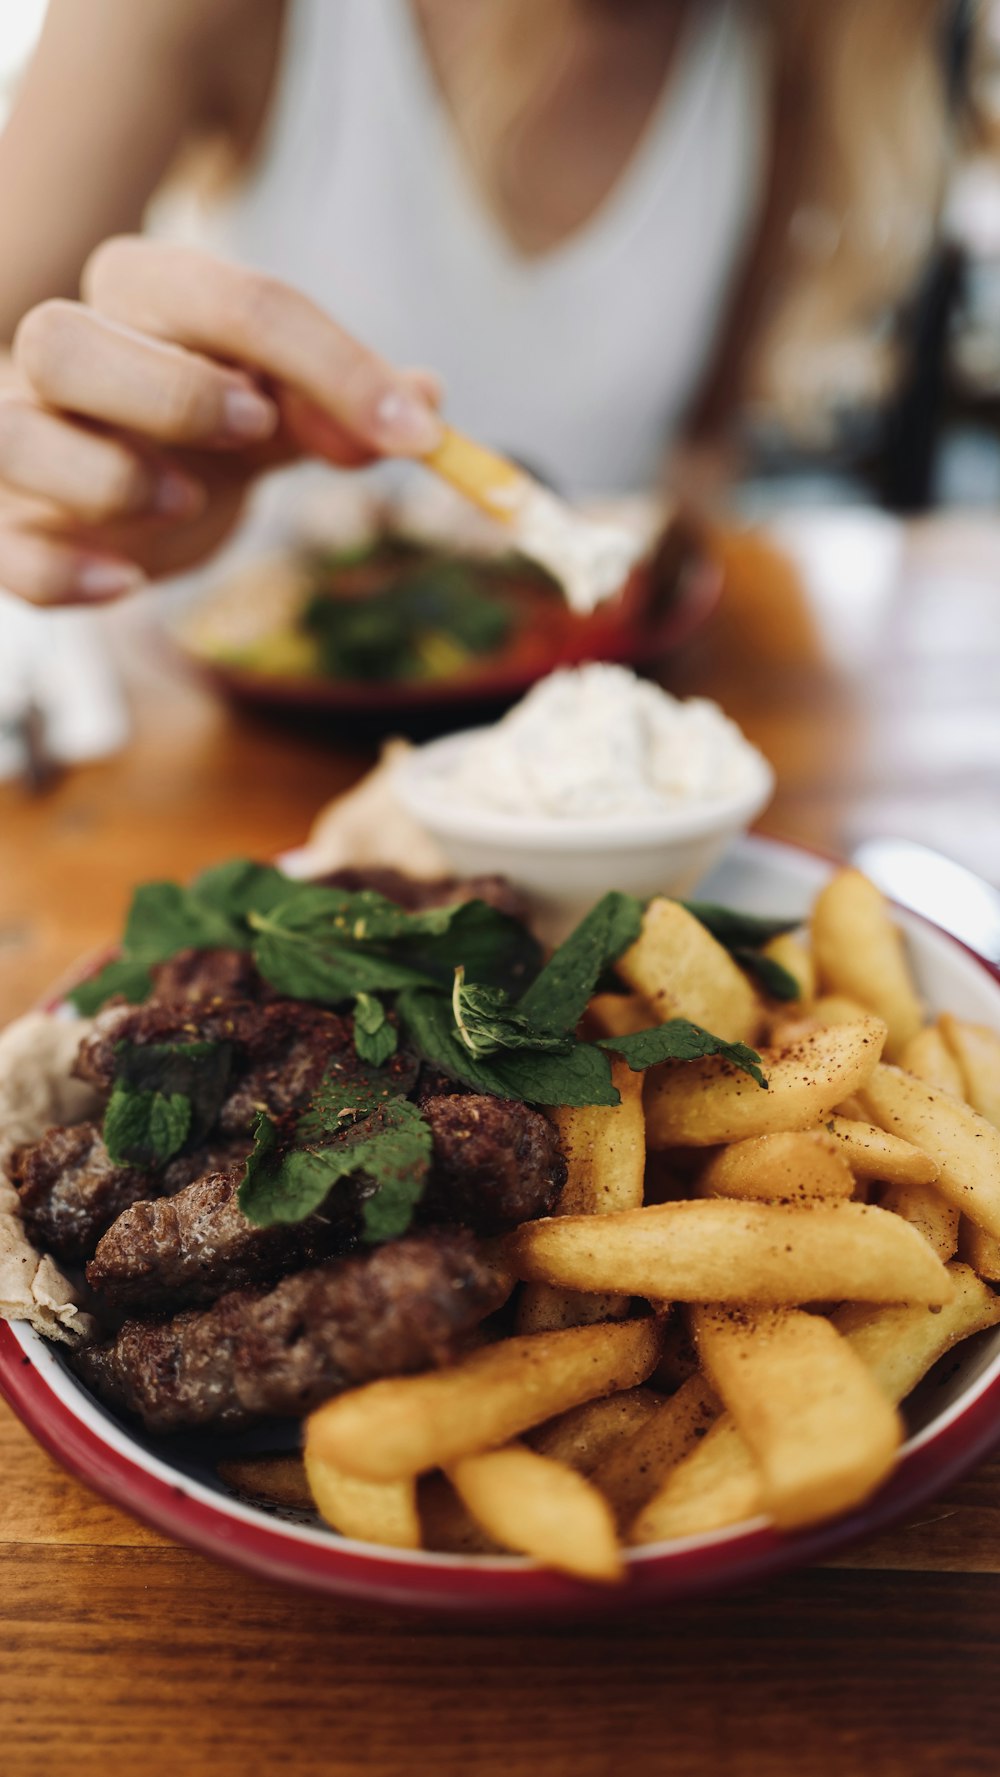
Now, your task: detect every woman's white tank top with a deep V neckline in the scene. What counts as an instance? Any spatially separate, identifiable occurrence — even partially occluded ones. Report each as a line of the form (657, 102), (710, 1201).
(155, 0), (766, 494)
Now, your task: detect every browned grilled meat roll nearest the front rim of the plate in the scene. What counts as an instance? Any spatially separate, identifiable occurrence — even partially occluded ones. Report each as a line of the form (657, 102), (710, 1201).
(75, 1230), (504, 1432)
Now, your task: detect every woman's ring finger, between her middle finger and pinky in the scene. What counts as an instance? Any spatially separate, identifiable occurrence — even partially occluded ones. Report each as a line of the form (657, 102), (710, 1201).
(0, 400), (204, 524)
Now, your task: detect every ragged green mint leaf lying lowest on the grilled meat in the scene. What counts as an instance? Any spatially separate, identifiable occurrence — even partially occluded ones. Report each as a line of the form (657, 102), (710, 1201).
(240, 1079), (432, 1240)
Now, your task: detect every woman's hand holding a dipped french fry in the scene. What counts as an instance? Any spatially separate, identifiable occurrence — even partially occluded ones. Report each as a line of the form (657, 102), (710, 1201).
(0, 238), (440, 604)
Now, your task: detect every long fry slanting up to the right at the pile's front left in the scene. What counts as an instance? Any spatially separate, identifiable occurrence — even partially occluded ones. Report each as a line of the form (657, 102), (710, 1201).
(309, 1322), (659, 1480)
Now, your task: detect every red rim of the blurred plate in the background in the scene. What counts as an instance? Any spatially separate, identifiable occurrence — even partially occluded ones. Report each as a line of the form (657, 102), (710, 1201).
(167, 556), (723, 714)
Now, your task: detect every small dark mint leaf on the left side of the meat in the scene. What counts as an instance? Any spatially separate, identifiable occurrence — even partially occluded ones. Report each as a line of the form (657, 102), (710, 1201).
(103, 1043), (233, 1166)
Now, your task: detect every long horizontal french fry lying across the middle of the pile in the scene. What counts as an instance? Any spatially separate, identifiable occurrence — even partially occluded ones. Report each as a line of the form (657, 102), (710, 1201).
(507, 1198), (950, 1307)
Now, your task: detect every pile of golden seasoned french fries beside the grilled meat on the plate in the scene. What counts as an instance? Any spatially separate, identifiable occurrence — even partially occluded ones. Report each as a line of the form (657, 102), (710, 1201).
(236, 871), (1000, 1582)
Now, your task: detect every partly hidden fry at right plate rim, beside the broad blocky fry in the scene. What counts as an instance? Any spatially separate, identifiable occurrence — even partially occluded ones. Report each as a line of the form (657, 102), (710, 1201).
(833, 1260), (1000, 1404)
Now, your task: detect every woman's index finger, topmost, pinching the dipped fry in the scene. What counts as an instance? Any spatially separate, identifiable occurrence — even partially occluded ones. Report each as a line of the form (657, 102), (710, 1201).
(83, 238), (440, 460)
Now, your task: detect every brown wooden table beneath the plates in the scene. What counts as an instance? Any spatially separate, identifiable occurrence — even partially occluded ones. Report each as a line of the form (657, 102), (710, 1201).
(0, 521), (1000, 1777)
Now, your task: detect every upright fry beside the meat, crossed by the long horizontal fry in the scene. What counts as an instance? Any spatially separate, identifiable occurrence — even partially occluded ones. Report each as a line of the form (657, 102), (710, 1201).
(517, 1061), (647, 1333)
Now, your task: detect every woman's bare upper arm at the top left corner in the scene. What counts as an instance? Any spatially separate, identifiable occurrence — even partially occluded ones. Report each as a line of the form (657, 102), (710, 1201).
(0, 0), (275, 343)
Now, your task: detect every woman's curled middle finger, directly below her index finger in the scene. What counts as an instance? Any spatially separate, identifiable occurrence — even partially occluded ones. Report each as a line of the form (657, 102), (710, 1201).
(14, 302), (279, 446)
